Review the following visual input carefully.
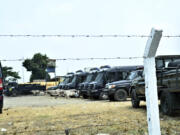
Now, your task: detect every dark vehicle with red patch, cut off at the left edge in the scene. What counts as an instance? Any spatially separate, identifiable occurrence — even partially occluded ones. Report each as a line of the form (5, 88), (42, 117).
(0, 62), (3, 114)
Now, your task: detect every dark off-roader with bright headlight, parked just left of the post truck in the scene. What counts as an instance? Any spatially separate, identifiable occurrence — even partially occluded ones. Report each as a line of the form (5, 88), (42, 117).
(103, 66), (143, 101)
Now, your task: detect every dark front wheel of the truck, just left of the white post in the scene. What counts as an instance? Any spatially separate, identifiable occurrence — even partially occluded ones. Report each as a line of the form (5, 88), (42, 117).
(131, 90), (140, 108)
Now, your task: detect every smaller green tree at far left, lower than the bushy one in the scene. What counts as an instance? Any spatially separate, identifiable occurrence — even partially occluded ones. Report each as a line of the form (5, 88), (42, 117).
(2, 66), (21, 81)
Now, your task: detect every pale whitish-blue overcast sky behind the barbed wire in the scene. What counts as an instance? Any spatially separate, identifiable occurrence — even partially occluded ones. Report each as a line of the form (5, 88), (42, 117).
(0, 0), (180, 82)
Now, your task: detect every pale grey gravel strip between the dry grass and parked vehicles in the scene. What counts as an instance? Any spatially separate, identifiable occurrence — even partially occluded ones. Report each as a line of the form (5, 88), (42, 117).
(4, 95), (102, 109)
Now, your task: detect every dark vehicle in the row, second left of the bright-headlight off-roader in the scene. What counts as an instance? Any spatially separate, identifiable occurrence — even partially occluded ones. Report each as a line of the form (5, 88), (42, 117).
(78, 68), (99, 98)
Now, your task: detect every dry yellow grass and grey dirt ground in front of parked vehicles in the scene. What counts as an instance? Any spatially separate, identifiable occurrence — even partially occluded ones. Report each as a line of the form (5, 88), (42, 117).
(0, 96), (180, 135)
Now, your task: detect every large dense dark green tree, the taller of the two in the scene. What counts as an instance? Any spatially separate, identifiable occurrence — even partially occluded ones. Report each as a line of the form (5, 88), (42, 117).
(23, 53), (50, 82)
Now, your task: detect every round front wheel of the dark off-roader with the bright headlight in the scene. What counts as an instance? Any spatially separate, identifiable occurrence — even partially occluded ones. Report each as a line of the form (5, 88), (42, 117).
(114, 89), (127, 101)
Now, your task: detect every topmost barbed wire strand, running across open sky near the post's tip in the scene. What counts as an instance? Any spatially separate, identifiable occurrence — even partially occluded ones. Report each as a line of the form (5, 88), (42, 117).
(0, 34), (180, 38)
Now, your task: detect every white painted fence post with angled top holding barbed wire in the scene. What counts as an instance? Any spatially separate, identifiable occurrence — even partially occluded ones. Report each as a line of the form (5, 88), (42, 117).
(144, 29), (162, 135)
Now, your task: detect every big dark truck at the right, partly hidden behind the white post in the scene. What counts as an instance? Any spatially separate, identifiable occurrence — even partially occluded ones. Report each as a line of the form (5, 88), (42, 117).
(130, 55), (180, 115)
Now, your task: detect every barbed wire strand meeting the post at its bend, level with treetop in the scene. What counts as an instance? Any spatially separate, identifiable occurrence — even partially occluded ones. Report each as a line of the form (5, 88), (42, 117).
(0, 57), (144, 62)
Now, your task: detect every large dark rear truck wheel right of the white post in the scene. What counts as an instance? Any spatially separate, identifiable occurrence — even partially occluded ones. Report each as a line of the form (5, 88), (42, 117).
(160, 91), (176, 116)
